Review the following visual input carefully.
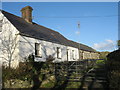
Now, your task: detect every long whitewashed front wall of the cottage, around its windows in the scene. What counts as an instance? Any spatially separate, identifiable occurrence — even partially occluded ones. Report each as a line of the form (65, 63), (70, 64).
(19, 36), (79, 62)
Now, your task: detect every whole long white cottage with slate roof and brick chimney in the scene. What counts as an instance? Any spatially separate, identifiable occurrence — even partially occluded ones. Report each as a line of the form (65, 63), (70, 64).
(0, 6), (99, 67)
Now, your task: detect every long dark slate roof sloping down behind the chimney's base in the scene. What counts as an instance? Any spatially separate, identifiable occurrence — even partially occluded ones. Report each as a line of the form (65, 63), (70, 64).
(2, 10), (96, 52)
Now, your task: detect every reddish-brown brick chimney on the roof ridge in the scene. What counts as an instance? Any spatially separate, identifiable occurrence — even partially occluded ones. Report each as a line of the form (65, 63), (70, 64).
(21, 6), (33, 24)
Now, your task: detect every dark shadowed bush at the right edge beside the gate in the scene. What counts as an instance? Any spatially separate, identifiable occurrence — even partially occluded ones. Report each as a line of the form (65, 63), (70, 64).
(107, 50), (120, 90)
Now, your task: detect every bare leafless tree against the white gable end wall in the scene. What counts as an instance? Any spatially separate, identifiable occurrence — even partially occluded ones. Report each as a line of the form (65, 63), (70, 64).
(0, 18), (18, 68)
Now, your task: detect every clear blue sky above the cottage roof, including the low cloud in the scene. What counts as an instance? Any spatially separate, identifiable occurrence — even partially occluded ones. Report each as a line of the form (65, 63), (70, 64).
(2, 2), (118, 51)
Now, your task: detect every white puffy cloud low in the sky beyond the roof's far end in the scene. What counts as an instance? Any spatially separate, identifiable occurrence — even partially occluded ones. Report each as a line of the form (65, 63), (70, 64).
(93, 39), (116, 50)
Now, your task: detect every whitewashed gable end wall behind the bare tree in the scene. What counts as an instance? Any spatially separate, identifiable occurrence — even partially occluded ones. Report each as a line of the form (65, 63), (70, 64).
(0, 12), (19, 67)
